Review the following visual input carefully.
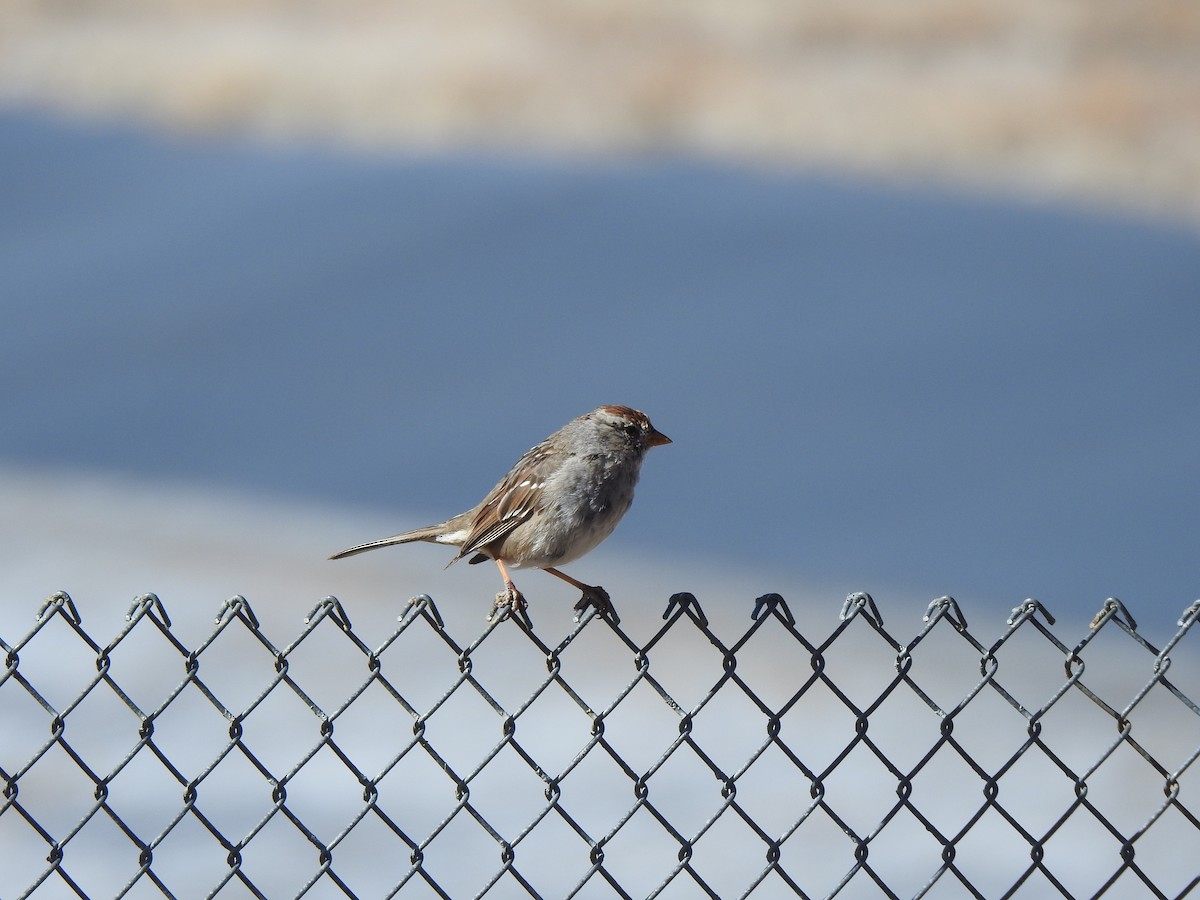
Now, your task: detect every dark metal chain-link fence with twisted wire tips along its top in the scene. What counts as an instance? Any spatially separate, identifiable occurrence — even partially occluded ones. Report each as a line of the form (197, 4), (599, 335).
(0, 594), (1200, 900)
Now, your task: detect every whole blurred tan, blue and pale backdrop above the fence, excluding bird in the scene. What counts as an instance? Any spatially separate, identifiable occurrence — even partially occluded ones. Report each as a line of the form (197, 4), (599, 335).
(0, 0), (1200, 897)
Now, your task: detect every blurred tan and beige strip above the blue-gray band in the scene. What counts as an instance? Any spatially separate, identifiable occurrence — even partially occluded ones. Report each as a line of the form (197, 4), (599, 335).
(0, 0), (1200, 226)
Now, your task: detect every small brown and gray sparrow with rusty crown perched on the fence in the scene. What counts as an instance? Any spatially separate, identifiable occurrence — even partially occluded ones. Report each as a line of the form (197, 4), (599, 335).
(330, 406), (671, 613)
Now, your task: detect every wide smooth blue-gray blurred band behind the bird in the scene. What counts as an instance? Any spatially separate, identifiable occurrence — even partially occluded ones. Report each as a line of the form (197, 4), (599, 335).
(0, 114), (1200, 630)
